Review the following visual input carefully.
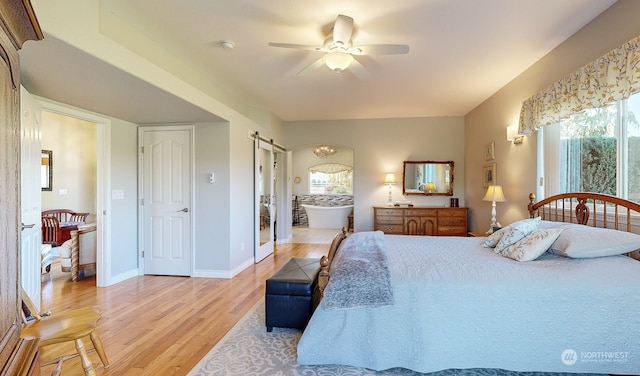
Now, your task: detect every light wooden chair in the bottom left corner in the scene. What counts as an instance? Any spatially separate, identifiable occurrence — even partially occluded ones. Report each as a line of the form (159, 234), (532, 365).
(20, 290), (109, 376)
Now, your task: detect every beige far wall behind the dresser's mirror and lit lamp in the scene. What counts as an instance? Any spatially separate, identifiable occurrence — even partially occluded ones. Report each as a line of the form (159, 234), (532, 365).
(284, 117), (465, 231)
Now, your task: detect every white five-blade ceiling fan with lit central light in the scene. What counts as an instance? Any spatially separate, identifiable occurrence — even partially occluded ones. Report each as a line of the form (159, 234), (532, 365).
(269, 14), (409, 80)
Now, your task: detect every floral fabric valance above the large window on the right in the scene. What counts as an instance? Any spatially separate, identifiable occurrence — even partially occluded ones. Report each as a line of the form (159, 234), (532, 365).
(518, 36), (640, 134)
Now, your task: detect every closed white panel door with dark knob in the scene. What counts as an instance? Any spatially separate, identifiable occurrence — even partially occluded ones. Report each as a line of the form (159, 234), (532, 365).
(139, 127), (193, 276)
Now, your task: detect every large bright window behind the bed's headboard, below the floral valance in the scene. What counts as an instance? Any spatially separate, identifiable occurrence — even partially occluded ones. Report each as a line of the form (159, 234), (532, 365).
(539, 95), (640, 202)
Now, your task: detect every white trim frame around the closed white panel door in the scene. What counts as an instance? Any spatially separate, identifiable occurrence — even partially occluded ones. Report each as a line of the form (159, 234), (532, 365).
(138, 124), (192, 277)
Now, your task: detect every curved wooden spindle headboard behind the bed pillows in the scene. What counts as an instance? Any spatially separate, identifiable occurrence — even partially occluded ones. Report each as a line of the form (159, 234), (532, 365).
(528, 192), (640, 234)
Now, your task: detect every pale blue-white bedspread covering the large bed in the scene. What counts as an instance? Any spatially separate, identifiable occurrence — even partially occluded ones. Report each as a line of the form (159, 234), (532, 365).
(298, 235), (640, 374)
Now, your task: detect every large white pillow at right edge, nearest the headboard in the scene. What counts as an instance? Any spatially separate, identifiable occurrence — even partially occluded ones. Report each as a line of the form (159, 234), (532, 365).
(549, 224), (640, 258)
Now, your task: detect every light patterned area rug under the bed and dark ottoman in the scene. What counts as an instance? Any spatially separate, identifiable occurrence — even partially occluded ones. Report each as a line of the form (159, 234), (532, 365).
(189, 300), (600, 376)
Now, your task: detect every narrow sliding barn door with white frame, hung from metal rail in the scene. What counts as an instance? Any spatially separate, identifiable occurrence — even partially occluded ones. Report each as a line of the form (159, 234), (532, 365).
(254, 139), (276, 262)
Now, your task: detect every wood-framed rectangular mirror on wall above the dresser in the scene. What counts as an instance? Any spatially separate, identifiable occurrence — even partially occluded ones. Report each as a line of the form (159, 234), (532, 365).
(402, 161), (453, 196)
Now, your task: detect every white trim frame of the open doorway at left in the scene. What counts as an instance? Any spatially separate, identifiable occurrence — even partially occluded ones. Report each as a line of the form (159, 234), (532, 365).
(33, 95), (113, 287)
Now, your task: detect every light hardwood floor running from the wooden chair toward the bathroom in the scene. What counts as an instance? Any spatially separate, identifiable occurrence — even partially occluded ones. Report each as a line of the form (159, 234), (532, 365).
(42, 243), (329, 376)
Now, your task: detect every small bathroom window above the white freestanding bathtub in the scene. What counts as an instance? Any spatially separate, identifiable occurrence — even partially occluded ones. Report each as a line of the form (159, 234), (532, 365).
(309, 163), (353, 194)
